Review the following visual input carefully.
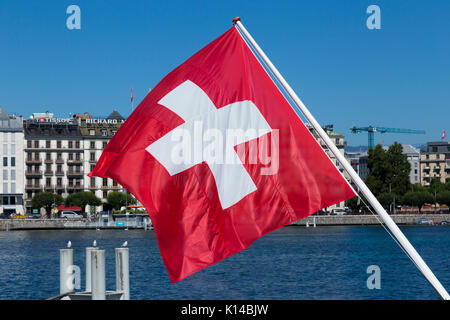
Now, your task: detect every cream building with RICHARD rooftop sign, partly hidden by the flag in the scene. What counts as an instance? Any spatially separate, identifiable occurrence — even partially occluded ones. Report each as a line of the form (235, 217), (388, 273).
(78, 110), (126, 212)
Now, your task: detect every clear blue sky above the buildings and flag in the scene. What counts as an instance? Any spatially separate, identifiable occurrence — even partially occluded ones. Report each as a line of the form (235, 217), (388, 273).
(0, 0), (450, 145)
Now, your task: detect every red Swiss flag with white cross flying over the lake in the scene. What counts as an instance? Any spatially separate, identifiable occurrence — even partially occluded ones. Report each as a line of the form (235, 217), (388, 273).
(89, 27), (355, 282)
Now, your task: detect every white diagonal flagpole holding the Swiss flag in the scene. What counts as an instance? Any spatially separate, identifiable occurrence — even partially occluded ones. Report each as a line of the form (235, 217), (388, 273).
(233, 17), (450, 300)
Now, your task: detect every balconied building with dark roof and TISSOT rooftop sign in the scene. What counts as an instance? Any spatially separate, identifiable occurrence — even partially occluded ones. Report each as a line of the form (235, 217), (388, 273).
(23, 112), (84, 213)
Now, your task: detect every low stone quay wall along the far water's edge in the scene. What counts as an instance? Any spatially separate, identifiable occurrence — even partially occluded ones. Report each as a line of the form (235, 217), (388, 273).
(0, 213), (450, 231)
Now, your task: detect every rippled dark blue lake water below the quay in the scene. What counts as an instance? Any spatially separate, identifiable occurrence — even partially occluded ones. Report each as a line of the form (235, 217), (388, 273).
(0, 226), (450, 300)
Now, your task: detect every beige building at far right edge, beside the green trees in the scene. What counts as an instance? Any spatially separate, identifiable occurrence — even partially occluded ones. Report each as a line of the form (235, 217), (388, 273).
(420, 142), (450, 186)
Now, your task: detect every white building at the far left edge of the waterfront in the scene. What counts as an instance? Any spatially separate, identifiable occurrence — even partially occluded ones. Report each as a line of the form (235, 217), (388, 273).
(0, 107), (24, 215)
